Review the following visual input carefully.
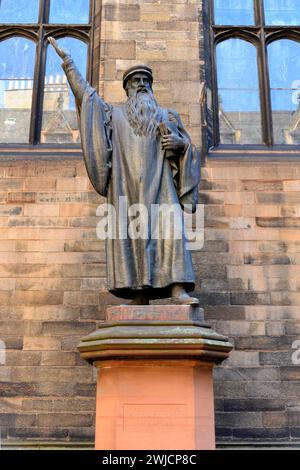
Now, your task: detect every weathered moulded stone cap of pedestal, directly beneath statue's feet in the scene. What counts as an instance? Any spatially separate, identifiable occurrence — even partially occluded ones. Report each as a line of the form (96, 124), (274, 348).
(78, 305), (232, 367)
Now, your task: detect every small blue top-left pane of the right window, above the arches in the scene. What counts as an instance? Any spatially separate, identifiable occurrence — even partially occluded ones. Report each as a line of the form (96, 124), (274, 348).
(215, 0), (255, 25)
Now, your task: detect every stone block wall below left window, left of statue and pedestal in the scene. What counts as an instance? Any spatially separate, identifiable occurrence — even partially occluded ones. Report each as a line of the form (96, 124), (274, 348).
(0, 157), (103, 441)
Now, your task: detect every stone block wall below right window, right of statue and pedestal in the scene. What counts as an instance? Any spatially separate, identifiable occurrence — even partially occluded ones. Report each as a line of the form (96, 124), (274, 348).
(200, 158), (300, 442)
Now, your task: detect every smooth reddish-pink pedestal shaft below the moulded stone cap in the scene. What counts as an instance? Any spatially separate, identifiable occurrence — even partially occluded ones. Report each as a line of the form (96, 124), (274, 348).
(96, 360), (215, 450)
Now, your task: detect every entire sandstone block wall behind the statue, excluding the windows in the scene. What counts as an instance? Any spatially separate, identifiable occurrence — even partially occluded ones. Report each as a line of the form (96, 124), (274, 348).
(0, 0), (300, 444)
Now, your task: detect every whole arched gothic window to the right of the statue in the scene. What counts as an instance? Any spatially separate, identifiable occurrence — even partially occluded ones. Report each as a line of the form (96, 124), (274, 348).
(203, 0), (300, 150)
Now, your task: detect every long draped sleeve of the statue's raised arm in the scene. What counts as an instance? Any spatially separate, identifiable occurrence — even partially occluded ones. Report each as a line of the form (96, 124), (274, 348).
(62, 56), (113, 197)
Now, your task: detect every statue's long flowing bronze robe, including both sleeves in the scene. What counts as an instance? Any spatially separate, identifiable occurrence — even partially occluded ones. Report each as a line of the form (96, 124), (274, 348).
(63, 57), (200, 299)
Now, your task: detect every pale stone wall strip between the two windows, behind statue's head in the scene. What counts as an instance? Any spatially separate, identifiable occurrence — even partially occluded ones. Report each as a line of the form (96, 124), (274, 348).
(99, 0), (201, 145)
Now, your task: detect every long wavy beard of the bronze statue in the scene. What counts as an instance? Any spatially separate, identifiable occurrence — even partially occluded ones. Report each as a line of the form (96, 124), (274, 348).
(126, 90), (162, 137)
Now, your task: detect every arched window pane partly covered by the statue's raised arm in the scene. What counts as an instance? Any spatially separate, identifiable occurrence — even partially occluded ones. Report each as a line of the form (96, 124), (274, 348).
(41, 38), (88, 144)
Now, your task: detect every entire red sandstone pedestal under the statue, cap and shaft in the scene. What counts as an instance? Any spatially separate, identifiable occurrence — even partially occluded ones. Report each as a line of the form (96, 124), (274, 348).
(79, 305), (232, 450)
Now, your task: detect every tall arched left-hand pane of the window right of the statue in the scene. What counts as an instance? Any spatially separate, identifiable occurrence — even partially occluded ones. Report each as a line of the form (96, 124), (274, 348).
(217, 39), (262, 144)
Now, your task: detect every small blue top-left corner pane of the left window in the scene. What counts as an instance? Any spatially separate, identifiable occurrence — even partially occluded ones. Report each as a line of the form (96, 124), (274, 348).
(0, 0), (39, 23)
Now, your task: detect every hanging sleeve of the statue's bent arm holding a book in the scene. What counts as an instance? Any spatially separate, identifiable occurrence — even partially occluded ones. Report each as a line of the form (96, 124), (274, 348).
(171, 110), (201, 212)
